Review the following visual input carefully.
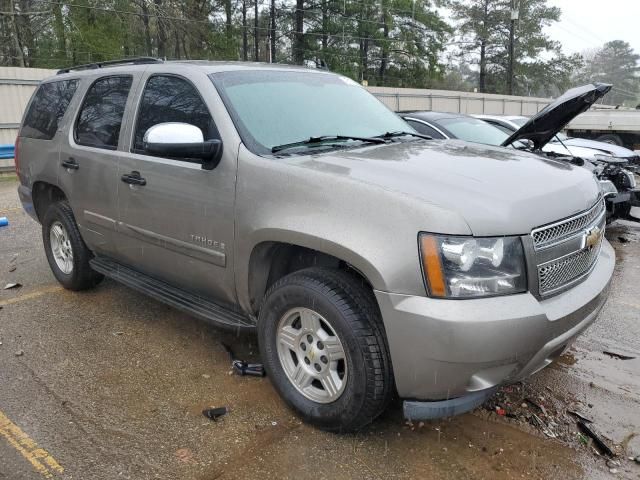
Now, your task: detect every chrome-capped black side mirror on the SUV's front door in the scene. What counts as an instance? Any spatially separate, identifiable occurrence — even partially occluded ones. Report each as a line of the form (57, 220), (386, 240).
(143, 122), (222, 170)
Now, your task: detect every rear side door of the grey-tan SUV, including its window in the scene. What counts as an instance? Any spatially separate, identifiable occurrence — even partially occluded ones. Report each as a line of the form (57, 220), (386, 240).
(59, 74), (139, 255)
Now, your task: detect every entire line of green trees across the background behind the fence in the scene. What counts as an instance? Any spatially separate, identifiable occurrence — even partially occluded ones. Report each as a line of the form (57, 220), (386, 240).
(0, 0), (638, 98)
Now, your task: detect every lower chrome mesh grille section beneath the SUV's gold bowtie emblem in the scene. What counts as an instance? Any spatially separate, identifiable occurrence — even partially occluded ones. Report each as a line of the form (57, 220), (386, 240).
(538, 242), (602, 295)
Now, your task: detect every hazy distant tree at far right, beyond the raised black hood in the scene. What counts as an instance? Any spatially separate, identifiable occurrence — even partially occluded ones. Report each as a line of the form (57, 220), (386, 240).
(577, 40), (640, 106)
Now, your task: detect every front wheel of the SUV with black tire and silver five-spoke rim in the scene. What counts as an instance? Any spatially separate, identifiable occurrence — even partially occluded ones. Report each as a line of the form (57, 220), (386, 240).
(258, 268), (395, 432)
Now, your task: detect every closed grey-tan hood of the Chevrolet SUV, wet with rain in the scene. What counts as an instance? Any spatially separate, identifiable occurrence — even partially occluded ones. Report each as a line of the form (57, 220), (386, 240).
(298, 140), (599, 236)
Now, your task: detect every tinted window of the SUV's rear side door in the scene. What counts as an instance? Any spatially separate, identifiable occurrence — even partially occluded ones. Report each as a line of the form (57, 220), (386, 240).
(74, 76), (133, 150)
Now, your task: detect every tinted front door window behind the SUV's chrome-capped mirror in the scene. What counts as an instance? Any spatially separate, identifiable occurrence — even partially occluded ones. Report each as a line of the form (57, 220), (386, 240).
(133, 75), (219, 153)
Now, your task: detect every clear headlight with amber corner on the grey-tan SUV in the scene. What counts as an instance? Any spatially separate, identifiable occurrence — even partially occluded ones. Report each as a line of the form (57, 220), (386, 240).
(420, 233), (527, 298)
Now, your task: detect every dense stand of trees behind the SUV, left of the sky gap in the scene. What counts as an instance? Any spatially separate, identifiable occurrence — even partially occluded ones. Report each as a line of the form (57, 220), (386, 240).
(0, 0), (451, 87)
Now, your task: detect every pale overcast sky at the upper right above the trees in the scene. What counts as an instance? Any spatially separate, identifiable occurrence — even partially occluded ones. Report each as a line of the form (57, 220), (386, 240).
(547, 0), (640, 53)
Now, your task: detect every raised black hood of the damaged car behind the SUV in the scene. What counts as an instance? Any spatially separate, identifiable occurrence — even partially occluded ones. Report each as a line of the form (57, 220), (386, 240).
(502, 83), (612, 150)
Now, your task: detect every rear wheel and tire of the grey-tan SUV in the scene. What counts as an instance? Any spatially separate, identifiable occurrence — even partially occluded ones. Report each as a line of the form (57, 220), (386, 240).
(42, 200), (104, 291)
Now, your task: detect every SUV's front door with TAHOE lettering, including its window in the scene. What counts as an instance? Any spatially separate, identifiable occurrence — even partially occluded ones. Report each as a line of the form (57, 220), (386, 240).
(118, 74), (237, 303)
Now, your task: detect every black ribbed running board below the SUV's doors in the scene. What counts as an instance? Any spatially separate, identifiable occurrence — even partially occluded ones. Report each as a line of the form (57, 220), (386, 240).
(89, 257), (255, 330)
